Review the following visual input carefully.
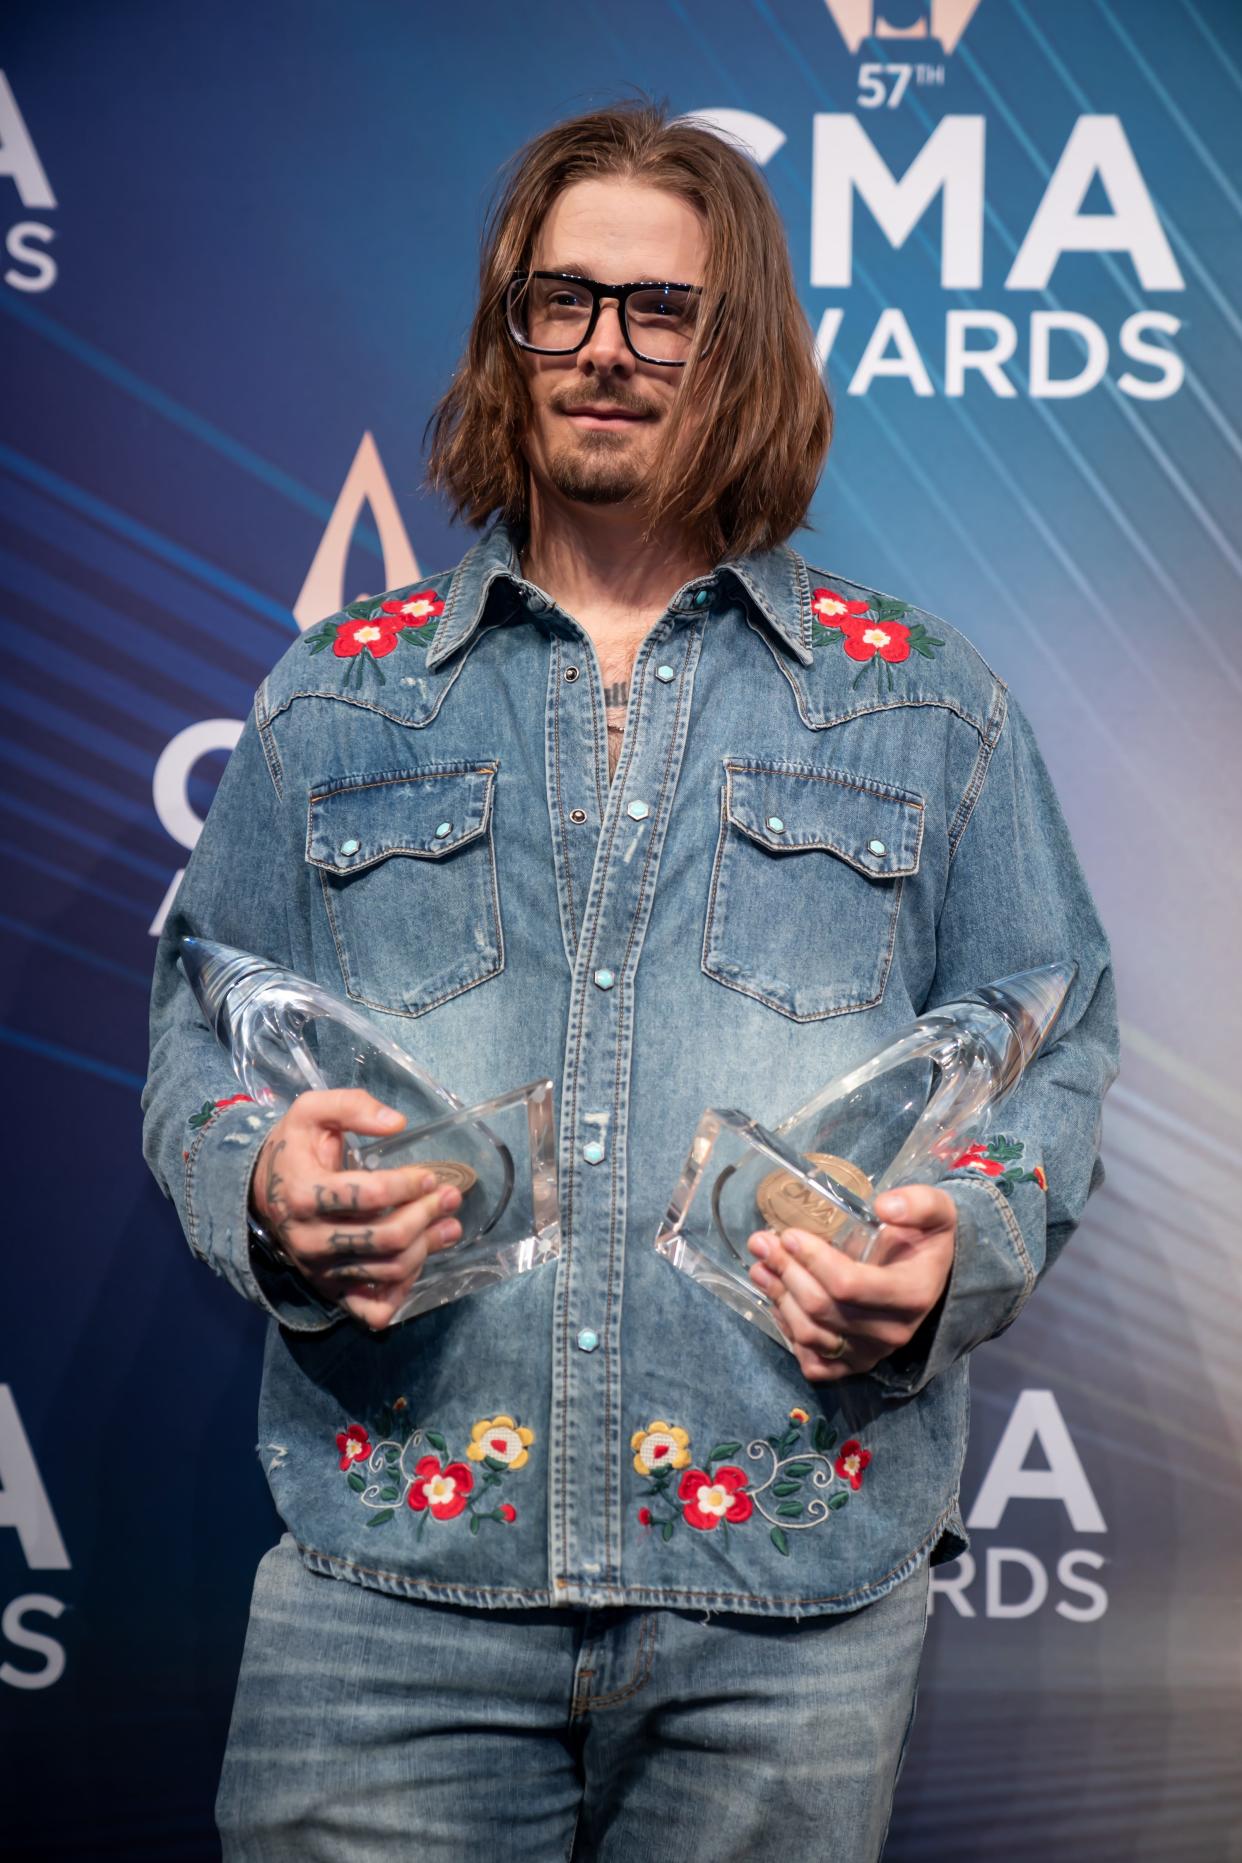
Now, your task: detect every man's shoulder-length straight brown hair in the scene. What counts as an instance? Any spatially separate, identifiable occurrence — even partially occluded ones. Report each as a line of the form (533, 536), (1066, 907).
(428, 101), (832, 561)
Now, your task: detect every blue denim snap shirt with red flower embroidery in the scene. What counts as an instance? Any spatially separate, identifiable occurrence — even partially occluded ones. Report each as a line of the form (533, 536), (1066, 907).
(143, 524), (1117, 1617)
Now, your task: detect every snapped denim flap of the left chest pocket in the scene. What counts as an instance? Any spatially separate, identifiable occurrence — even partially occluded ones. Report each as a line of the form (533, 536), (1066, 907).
(305, 764), (495, 874)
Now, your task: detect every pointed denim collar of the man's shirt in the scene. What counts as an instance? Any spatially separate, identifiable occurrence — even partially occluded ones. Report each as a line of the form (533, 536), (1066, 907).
(426, 518), (812, 673)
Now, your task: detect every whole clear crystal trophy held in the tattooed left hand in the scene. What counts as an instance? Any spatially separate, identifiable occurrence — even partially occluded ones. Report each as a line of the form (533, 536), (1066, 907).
(181, 937), (560, 1325)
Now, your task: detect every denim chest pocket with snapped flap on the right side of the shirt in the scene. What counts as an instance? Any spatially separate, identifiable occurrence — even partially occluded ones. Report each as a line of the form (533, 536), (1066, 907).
(702, 756), (924, 1023)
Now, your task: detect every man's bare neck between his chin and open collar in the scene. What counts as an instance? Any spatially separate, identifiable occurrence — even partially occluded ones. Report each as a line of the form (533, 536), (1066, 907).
(521, 486), (711, 641)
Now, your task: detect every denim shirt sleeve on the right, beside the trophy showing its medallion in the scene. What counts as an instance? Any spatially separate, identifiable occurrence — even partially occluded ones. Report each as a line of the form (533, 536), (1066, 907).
(871, 697), (1119, 1397)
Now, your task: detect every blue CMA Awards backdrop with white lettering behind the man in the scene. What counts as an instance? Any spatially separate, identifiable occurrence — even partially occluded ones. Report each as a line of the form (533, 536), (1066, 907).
(0, 0), (1242, 1863)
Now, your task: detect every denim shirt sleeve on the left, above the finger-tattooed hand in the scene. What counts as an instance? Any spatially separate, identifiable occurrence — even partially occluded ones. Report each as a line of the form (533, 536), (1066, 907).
(142, 693), (343, 1332)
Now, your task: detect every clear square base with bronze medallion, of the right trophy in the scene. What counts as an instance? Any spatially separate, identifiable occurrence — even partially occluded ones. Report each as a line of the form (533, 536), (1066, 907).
(655, 1107), (881, 1353)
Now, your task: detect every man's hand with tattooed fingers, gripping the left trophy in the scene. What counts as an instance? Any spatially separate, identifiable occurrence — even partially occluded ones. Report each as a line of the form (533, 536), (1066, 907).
(250, 1088), (462, 1330)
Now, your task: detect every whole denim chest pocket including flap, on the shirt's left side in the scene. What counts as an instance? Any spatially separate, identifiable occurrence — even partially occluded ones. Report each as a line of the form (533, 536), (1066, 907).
(305, 762), (505, 1015)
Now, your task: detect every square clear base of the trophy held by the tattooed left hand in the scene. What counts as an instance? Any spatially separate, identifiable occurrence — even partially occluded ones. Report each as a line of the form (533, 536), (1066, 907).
(346, 1081), (560, 1325)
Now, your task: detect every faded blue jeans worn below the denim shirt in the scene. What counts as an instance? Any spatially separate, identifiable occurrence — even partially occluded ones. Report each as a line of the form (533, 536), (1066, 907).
(216, 1535), (927, 1863)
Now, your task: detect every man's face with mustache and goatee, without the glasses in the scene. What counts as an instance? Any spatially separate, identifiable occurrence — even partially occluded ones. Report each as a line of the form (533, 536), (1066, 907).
(520, 179), (708, 505)
